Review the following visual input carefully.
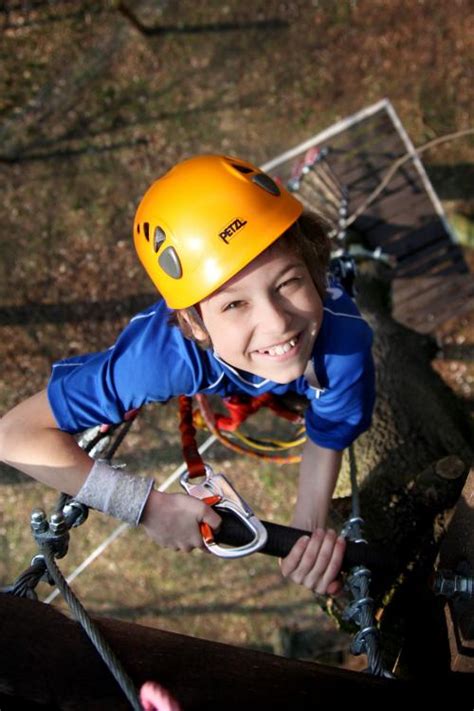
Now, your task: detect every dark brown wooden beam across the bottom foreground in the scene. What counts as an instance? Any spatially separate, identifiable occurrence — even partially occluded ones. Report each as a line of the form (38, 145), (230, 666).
(0, 595), (469, 711)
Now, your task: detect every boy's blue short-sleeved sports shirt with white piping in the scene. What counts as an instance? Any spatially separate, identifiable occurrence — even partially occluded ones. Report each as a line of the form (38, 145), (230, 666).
(48, 283), (375, 450)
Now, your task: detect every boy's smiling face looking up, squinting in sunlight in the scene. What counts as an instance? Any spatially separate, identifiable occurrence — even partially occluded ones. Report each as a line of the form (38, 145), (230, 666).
(193, 242), (323, 383)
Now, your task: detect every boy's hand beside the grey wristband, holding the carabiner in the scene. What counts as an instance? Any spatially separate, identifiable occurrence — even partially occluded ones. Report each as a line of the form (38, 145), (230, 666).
(140, 490), (221, 553)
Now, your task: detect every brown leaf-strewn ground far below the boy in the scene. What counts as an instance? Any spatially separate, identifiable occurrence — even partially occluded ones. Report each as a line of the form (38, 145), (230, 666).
(0, 0), (474, 676)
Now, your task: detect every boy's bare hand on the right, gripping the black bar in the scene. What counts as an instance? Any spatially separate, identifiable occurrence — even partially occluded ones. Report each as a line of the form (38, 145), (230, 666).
(280, 528), (346, 595)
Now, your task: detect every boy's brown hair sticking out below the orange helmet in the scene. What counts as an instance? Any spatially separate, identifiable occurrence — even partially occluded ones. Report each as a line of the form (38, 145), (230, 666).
(168, 210), (331, 350)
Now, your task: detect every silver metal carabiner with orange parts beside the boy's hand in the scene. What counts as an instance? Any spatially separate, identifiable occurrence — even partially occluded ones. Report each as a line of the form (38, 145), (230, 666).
(180, 464), (268, 558)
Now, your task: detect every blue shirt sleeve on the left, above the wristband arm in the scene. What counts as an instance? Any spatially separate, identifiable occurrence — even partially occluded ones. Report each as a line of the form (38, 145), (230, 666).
(48, 307), (202, 433)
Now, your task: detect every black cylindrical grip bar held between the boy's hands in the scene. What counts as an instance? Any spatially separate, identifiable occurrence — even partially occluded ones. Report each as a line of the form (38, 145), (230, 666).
(214, 510), (394, 571)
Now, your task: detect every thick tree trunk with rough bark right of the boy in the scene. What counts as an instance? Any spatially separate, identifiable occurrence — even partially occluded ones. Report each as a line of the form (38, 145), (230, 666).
(336, 264), (474, 549)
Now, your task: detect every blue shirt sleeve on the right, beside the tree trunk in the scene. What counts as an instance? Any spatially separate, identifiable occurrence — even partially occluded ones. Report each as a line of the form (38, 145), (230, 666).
(306, 320), (375, 450)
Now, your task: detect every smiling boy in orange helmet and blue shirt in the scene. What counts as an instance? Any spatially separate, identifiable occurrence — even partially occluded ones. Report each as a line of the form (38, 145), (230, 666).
(0, 155), (374, 594)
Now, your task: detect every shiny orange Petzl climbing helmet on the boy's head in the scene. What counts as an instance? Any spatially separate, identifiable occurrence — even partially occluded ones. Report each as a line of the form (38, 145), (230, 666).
(133, 155), (303, 309)
